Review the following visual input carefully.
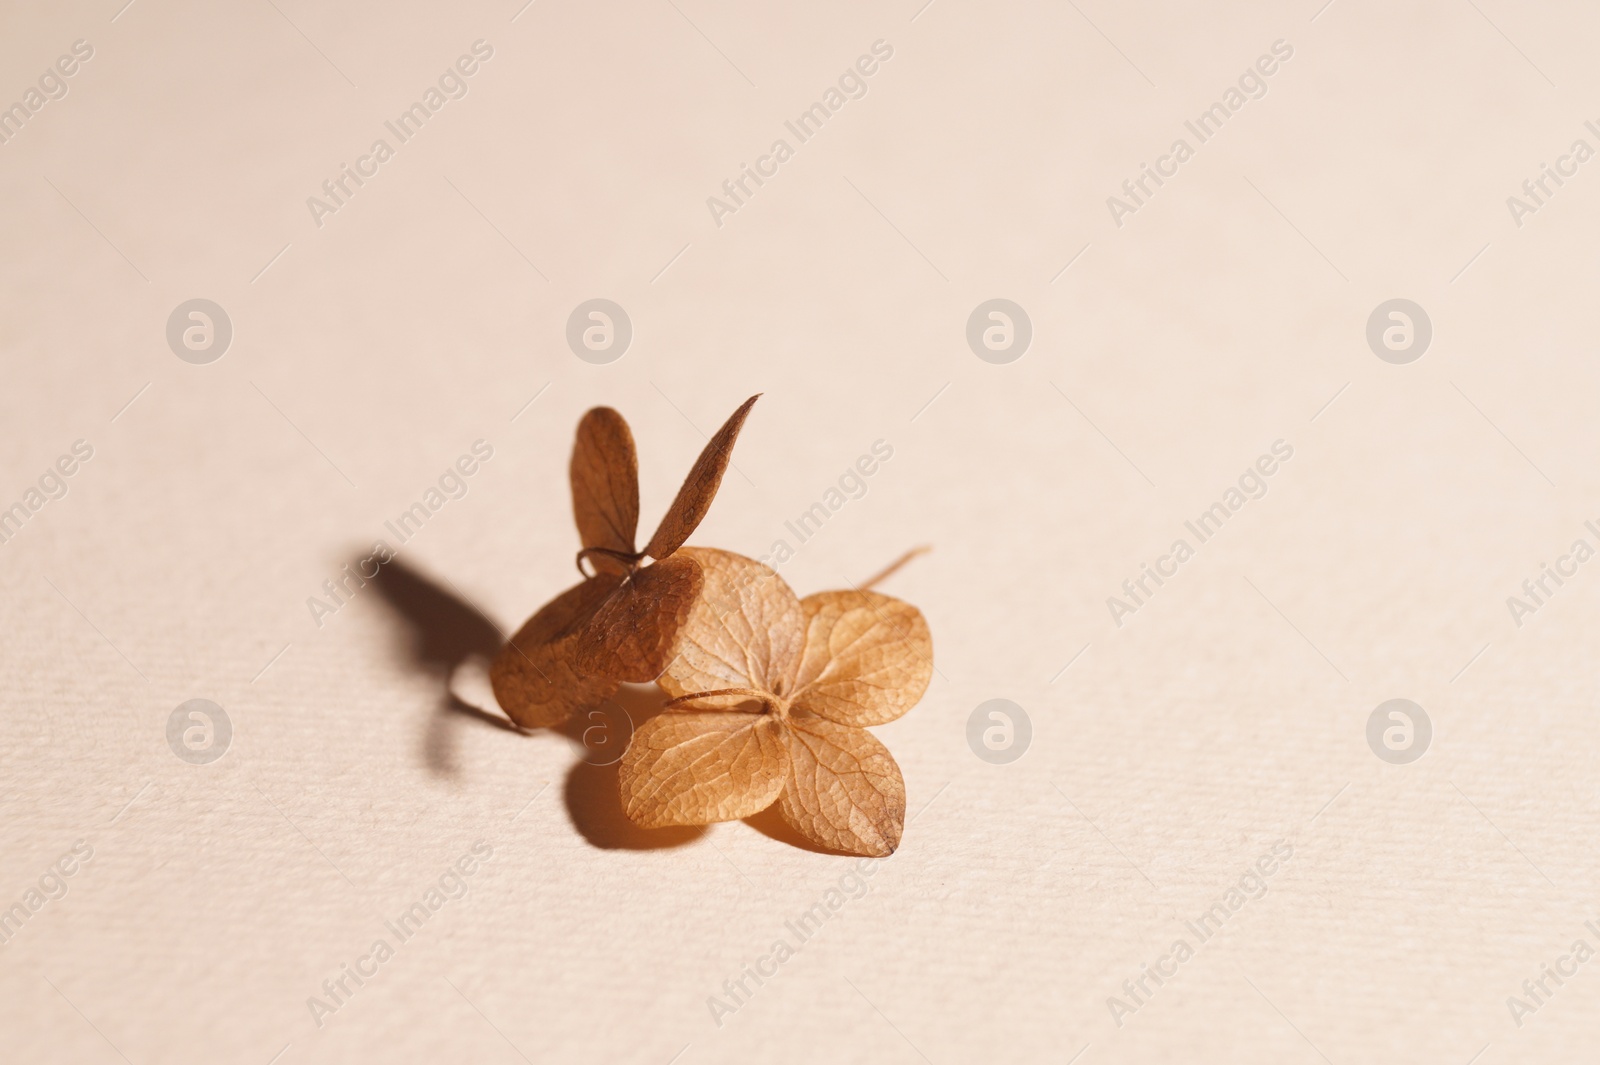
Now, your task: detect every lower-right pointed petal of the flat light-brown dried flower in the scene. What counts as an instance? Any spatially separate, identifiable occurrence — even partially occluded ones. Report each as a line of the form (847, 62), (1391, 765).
(778, 715), (906, 857)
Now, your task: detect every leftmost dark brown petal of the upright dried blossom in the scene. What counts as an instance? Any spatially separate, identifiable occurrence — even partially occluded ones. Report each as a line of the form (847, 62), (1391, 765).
(490, 574), (619, 729)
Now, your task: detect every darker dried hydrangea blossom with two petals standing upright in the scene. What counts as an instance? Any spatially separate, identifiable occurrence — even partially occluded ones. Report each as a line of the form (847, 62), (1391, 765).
(490, 397), (758, 728)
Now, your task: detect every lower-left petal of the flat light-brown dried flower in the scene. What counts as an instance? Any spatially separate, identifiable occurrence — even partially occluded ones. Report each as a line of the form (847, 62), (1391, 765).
(621, 713), (789, 828)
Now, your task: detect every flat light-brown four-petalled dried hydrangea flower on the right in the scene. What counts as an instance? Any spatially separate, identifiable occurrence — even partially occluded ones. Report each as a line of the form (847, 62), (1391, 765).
(621, 548), (933, 857)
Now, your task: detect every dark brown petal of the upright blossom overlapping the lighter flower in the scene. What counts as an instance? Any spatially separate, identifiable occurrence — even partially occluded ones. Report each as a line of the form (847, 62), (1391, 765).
(578, 546), (700, 688)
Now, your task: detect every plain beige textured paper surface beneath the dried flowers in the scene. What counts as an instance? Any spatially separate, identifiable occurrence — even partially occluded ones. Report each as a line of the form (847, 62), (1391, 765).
(0, 0), (1600, 1065)
